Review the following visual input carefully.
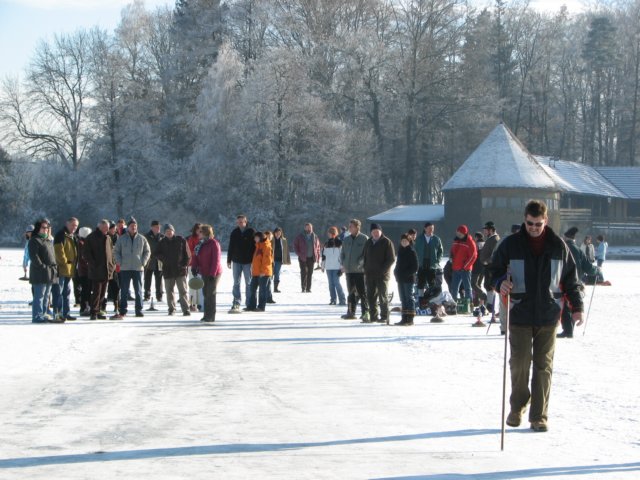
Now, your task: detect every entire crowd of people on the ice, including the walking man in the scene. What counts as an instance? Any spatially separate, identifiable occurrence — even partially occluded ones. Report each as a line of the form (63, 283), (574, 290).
(25, 200), (607, 432)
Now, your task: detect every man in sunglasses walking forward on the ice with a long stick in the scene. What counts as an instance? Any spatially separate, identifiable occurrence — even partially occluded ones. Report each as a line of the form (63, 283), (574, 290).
(491, 200), (582, 432)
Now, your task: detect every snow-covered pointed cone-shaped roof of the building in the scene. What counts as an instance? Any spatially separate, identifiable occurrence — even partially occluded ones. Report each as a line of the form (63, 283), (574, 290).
(442, 124), (557, 191)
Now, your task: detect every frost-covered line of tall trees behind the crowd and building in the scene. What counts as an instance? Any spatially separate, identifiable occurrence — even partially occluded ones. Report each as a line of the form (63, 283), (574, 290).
(0, 0), (640, 246)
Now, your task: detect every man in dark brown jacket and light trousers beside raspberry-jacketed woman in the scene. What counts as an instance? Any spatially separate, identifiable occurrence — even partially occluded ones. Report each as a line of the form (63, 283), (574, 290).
(156, 223), (191, 317)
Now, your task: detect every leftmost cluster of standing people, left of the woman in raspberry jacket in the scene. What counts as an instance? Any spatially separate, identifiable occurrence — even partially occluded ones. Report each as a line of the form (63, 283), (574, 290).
(23, 217), (191, 323)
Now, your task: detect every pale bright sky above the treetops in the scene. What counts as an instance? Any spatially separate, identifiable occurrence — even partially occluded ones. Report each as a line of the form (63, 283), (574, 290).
(0, 0), (585, 78)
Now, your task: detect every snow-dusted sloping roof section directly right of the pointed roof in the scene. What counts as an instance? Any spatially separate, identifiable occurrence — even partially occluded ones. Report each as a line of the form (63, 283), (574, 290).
(536, 157), (627, 198)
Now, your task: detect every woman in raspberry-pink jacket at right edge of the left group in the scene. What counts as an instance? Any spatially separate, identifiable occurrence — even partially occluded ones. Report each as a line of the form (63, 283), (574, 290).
(191, 224), (222, 323)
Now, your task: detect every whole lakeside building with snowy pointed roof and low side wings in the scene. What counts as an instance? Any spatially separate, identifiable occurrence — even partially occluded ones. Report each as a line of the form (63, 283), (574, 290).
(368, 123), (640, 244)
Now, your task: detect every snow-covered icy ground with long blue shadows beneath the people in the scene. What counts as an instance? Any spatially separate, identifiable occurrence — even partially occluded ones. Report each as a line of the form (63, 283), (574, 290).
(0, 249), (640, 479)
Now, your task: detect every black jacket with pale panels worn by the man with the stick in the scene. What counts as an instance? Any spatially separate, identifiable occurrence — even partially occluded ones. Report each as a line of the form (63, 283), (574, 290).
(490, 225), (582, 326)
